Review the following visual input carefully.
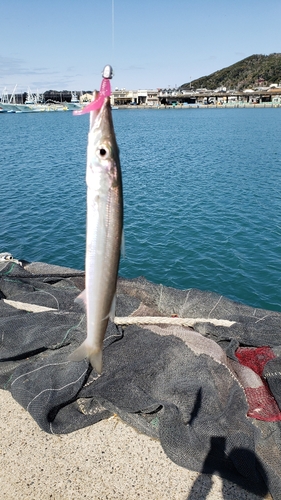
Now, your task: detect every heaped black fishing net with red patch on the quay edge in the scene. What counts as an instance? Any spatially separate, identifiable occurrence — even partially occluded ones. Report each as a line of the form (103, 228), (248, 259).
(0, 257), (281, 499)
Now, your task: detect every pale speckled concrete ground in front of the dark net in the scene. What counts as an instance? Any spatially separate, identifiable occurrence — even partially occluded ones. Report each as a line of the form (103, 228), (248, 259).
(0, 391), (271, 500)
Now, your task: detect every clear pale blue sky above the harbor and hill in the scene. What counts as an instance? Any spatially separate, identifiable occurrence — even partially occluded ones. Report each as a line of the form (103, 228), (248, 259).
(0, 0), (281, 95)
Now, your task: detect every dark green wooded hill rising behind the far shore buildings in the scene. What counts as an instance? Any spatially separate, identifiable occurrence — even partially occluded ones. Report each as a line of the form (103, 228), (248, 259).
(180, 53), (281, 90)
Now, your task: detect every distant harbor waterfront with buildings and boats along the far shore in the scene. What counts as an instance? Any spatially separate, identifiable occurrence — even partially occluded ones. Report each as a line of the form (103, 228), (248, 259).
(0, 84), (281, 113)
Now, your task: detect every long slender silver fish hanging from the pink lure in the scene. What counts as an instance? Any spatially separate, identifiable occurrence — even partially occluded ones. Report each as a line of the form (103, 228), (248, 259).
(70, 92), (123, 374)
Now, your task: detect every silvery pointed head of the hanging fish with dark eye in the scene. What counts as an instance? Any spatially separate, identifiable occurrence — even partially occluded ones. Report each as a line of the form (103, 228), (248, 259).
(86, 97), (121, 189)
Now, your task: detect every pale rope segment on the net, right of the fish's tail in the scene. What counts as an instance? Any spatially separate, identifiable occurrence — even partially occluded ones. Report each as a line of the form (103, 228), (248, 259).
(114, 316), (236, 327)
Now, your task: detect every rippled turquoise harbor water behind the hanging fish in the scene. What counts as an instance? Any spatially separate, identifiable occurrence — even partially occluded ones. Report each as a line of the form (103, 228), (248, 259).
(0, 108), (281, 311)
